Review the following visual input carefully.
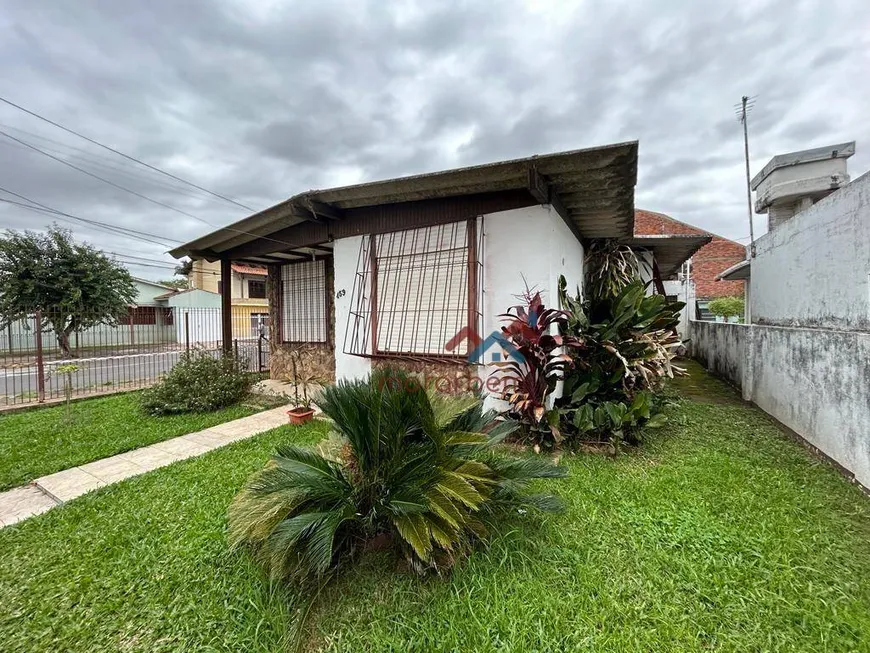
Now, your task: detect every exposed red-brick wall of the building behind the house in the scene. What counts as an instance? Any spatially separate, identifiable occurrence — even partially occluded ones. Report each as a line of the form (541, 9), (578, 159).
(634, 209), (746, 299)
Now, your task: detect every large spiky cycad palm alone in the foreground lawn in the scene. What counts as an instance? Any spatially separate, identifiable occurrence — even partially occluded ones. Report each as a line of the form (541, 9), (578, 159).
(229, 368), (565, 583)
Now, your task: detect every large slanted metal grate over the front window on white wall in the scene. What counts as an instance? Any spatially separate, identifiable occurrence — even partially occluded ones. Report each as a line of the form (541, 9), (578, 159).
(344, 219), (482, 360)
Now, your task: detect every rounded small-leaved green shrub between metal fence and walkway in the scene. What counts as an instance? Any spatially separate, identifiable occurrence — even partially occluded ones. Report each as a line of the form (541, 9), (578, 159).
(142, 350), (254, 415)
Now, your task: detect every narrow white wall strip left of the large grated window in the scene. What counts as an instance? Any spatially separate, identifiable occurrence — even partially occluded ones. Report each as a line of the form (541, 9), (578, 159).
(332, 236), (372, 381)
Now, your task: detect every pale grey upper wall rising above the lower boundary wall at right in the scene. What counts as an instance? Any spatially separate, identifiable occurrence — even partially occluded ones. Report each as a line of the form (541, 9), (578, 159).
(750, 173), (870, 331)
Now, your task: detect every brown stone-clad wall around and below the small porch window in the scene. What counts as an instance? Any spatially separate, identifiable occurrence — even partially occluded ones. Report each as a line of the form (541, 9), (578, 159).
(266, 259), (335, 383)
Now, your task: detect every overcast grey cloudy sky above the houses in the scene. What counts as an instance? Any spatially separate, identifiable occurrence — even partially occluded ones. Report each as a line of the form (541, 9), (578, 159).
(0, 0), (870, 278)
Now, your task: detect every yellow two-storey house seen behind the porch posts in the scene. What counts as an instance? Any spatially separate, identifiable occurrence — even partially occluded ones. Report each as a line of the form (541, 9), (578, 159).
(188, 259), (269, 338)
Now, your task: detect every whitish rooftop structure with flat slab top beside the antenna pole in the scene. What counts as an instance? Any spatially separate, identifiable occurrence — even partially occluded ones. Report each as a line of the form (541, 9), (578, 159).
(752, 141), (855, 231)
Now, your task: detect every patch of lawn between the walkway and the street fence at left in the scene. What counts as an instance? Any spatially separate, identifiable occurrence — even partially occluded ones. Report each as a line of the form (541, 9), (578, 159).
(0, 392), (282, 490)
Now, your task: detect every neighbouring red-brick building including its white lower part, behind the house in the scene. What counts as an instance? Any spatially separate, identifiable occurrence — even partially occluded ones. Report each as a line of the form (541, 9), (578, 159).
(634, 209), (746, 338)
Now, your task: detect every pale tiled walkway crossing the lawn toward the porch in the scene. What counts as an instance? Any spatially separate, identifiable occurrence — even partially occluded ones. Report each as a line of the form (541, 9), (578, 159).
(0, 406), (289, 528)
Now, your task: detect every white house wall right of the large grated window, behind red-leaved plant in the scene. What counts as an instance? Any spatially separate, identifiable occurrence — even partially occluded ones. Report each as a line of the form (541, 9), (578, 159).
(480, 206), (584, 408)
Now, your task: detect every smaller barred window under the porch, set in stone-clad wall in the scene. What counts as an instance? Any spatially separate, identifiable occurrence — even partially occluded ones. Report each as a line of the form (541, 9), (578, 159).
(281, 260), (328, 342)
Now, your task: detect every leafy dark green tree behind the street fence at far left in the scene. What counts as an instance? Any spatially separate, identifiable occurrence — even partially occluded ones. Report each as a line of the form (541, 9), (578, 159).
(0, 225), (136, 357)
